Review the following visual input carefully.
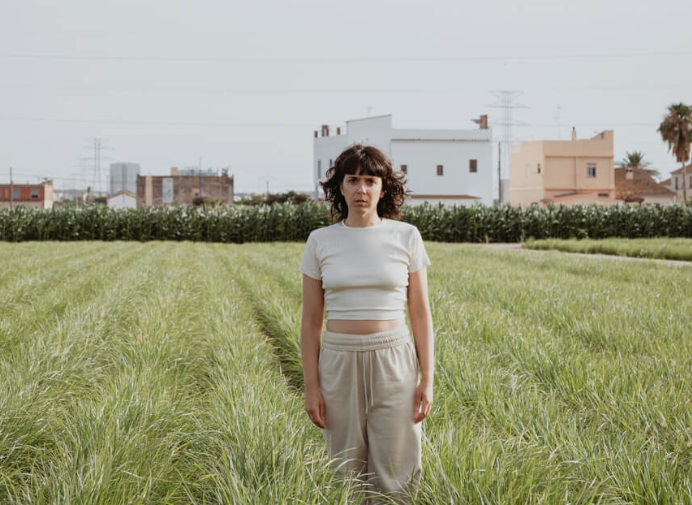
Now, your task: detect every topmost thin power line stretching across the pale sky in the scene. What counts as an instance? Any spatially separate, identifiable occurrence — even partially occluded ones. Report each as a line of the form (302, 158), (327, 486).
(0, 51), (692, 63)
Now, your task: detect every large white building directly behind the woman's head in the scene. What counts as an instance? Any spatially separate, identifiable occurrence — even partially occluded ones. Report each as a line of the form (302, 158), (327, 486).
(313, 114), (493, 205)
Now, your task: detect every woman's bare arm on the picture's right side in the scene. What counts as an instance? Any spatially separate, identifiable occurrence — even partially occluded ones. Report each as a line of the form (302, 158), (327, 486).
(408, 268), (435, 423)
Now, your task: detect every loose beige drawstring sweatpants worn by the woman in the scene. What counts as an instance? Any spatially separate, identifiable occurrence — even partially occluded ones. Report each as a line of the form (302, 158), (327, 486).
(319, 326), (421, 503)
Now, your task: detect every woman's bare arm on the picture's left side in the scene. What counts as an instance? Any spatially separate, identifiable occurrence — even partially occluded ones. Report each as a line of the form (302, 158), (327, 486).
(300, 274), (325, 428)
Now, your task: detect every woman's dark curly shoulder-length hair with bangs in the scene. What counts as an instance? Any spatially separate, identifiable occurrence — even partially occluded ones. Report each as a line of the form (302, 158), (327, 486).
(320, 144), (411, 221)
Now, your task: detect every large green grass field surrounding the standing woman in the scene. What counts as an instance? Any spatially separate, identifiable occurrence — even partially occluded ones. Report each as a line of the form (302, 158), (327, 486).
(0, 242), (692, 504)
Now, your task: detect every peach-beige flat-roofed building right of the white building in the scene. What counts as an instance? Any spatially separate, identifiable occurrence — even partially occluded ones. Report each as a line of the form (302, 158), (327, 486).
(509, 129), (616, 206)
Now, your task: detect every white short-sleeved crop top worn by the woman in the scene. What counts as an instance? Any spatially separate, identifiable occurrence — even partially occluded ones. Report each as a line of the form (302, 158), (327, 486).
(299, 219), (430, 320)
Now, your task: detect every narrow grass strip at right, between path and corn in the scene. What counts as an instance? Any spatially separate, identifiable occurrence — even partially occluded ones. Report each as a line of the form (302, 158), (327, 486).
(522, 238), (692, 261)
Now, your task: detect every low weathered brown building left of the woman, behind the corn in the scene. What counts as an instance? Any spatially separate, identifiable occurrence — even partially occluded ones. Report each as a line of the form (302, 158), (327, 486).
(137, 168), (233, 208)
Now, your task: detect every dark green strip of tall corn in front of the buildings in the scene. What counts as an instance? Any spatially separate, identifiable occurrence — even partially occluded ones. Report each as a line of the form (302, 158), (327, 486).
(0, 202), (692, 243)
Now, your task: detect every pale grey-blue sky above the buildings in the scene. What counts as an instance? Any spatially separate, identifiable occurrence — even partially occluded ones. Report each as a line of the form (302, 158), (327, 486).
(0, 0), (692, 192)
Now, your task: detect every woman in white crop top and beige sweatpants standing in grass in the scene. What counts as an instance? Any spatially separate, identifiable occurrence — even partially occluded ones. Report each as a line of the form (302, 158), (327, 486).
(300, 144), (433, 500)
